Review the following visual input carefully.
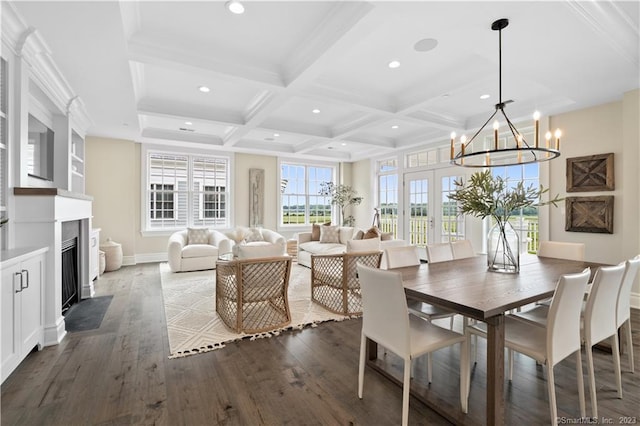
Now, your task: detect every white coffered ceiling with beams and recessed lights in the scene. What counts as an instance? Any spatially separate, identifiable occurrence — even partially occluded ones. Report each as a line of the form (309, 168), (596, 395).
(14, 1), (640, 161)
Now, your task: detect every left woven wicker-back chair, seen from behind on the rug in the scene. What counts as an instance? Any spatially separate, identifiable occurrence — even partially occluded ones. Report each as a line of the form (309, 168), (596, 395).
(216, 256), (291, 333)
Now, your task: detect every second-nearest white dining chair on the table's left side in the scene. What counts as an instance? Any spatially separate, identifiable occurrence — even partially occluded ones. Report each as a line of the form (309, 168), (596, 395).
(385, 246), (456, 383)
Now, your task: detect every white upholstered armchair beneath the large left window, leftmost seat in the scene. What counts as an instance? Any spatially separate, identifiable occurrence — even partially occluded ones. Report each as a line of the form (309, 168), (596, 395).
(167, 228), (232, 272)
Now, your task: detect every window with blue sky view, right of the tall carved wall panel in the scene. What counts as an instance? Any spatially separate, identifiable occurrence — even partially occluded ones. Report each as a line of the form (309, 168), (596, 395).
(280, 162), (335, 226)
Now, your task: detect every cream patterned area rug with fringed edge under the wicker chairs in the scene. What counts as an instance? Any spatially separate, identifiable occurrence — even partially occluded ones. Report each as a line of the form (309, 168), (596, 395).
(160, 263), (349, 358)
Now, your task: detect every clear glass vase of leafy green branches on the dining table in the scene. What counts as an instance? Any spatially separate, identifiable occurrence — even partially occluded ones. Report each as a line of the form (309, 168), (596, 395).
(449, 170), (560, 273)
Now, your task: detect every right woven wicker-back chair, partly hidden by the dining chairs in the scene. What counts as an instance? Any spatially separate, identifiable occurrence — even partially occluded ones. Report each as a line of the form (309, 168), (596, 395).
(311, 251), (382, 315)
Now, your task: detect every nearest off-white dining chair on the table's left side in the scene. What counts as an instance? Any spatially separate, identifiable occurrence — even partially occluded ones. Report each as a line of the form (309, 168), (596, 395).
(358, 264), (469, 425)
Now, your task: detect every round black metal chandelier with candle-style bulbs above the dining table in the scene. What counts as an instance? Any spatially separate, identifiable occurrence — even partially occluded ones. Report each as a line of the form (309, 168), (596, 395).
(451, 18), (562, 167)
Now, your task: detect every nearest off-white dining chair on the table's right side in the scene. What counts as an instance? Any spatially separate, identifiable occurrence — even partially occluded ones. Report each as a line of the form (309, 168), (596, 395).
(466, 268), (591, 425)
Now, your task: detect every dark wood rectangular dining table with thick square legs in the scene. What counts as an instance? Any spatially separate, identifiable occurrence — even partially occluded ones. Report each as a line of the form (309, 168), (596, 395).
(368, 255), (597, 425)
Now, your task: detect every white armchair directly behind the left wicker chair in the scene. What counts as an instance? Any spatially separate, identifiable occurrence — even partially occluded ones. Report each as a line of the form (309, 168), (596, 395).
(225, 227), (287, 259)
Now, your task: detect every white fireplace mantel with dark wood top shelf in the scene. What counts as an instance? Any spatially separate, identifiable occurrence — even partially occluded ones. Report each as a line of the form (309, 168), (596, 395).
(13, 188), (94, 346)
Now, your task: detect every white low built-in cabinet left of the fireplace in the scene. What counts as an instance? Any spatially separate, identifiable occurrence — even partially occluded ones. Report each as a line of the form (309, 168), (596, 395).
(0, 248), (48, 382)
